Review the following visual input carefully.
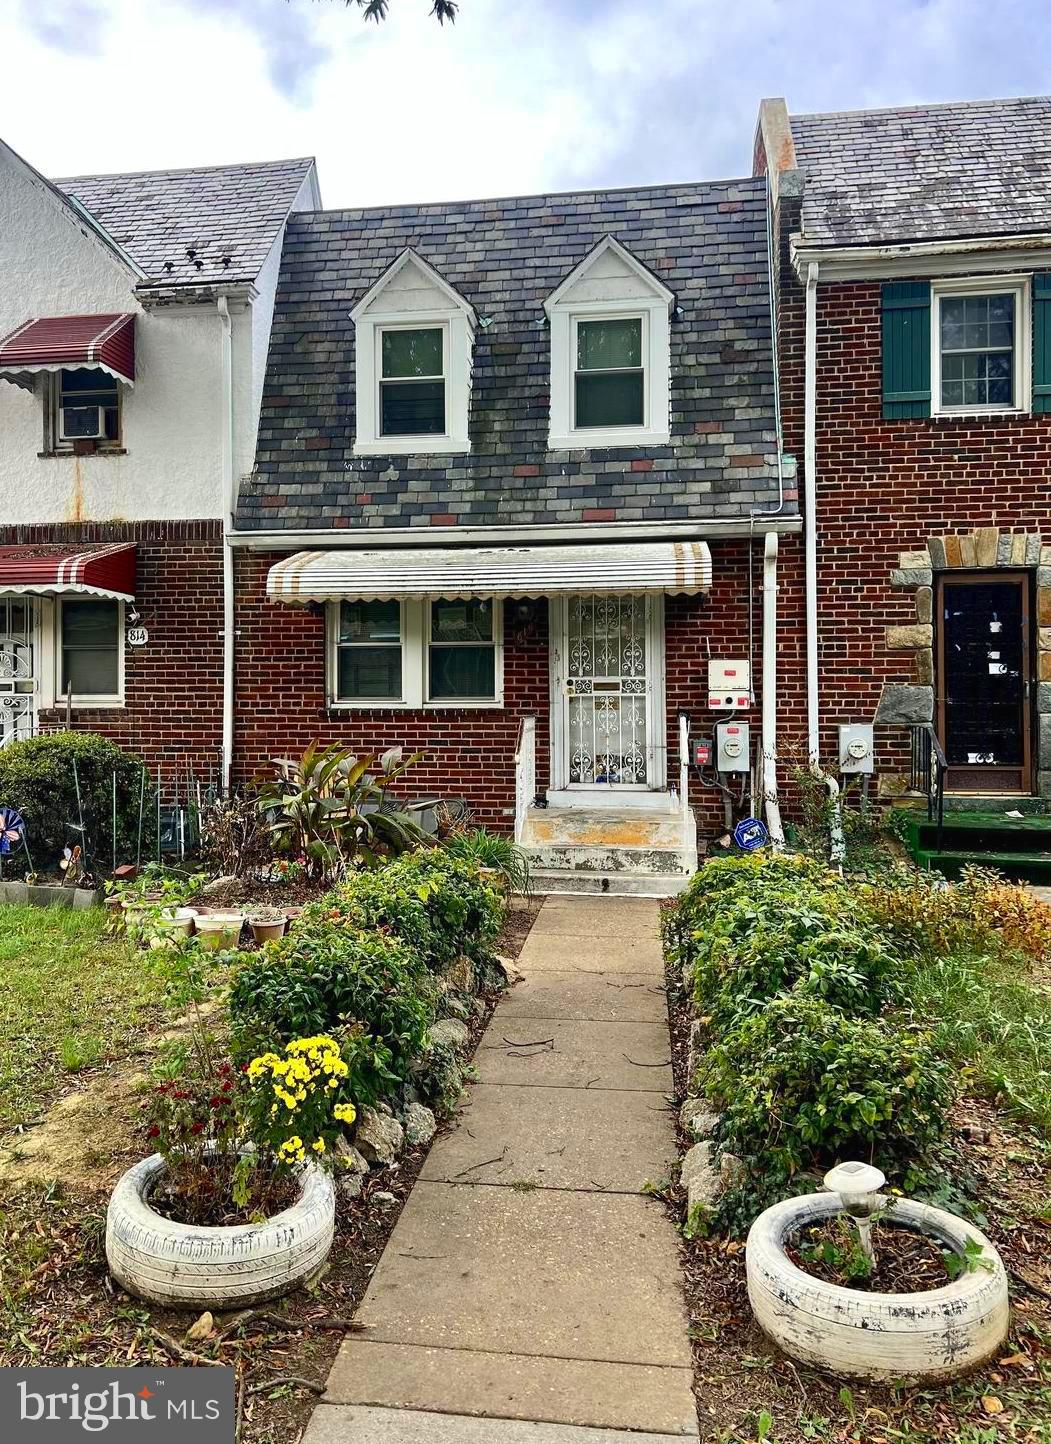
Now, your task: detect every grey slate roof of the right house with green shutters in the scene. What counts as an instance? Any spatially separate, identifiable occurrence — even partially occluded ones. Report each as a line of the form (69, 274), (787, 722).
(791, 95), (1051, 245)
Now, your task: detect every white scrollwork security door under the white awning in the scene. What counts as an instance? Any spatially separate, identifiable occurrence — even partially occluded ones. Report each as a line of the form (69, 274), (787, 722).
(566, 596), (653, 787)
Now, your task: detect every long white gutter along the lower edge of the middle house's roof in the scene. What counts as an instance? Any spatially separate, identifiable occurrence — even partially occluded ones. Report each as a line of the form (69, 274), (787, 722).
(227, 513), (803, 552)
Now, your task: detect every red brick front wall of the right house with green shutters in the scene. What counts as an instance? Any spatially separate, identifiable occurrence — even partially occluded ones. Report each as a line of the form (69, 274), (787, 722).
(778, 225), (1051, 791)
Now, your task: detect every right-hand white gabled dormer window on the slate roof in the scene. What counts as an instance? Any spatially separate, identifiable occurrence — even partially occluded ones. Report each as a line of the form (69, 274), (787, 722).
(544, 235), (674, 451)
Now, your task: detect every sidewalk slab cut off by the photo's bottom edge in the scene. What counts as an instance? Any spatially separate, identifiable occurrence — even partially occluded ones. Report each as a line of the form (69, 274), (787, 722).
(303, 1404), (697, 1444)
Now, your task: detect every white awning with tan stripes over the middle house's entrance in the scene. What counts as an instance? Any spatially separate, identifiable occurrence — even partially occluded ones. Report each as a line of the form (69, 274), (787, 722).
(267, 542), (712, 602)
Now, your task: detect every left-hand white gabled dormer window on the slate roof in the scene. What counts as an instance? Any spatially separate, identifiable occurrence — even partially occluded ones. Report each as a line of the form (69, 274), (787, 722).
(351, 250), (475, 456)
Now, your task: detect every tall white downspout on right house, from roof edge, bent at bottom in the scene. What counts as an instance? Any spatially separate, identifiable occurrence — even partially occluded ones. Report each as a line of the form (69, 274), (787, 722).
(803, 261), (846, 864)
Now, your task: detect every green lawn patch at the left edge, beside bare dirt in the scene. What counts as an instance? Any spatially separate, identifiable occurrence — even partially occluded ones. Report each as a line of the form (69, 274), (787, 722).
(0, 905), (170, 1129)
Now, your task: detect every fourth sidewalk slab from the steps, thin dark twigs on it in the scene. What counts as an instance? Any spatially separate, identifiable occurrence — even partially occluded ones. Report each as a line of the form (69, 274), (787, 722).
(475, 1009), (674, 1093)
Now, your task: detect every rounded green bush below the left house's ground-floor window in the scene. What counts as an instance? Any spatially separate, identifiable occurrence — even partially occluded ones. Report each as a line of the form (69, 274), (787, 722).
(0, 732), (156, 875)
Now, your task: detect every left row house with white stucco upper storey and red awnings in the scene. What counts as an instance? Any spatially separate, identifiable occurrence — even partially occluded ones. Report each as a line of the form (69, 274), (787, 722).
(0, 143), (319, 790)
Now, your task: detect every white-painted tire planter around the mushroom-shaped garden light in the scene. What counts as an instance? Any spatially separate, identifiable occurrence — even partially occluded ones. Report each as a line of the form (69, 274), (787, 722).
(745, 1193), (1009, 1380)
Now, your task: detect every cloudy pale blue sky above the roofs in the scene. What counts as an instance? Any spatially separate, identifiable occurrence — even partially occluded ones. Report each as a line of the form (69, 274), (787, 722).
(0, 0), (1051, 208)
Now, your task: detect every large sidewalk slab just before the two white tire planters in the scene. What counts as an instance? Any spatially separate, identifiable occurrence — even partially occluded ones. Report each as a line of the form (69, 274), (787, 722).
(358, 1180), (690, 1369)
